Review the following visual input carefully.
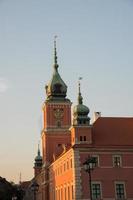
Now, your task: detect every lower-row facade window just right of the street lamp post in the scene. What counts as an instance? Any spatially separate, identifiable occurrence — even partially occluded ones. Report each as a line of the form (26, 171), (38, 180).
(92, 183), (101, 200)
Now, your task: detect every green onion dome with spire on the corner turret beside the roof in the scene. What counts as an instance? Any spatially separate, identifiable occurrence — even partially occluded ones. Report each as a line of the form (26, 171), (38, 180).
(73, 79), (90, 125)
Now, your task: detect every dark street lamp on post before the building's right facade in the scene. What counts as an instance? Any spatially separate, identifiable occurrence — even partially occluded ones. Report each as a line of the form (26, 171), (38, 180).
(83, 157), (96, 200)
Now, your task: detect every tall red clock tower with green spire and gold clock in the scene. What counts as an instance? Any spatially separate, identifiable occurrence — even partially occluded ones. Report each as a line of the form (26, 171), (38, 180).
(42, 41), (71, 164)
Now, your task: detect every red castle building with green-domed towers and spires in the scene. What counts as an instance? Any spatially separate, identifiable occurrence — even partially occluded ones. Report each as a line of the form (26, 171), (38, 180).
(34, 41), (133, 200)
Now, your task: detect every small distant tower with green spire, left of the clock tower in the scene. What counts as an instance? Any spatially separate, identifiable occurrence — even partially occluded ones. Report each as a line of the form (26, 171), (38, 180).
(34, 145), (42, 177)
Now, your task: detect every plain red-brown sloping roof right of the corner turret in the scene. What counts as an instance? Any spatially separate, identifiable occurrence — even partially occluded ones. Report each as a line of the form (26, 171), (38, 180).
(92, 117), (133, 146)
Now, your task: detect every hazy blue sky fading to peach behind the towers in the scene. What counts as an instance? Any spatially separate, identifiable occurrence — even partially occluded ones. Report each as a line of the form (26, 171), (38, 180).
(0, 0), (133, 182)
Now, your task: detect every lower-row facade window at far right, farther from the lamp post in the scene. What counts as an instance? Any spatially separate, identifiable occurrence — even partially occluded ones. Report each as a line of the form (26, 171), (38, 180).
(115, 183), (125, 200)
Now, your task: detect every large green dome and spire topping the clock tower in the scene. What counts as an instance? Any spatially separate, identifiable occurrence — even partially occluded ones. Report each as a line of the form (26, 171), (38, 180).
(45, 37), (67, 100)
